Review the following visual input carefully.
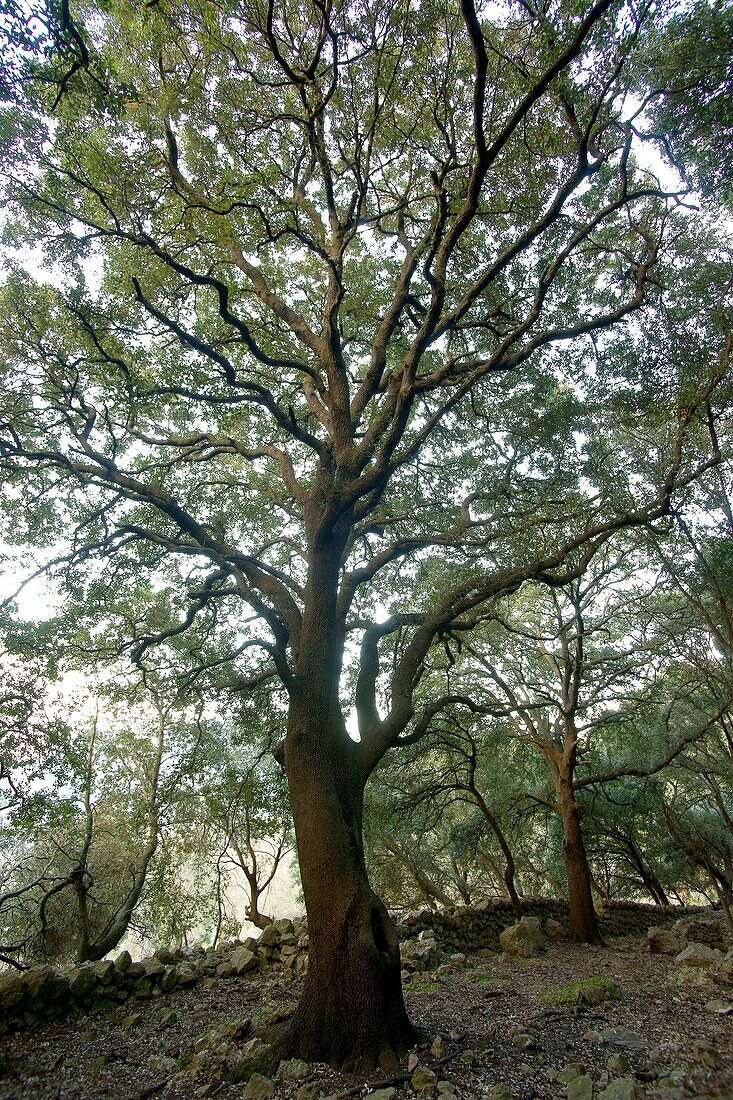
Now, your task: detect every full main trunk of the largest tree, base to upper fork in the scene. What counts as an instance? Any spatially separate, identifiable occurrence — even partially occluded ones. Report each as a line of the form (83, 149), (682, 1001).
(275, 528), (417, 1071)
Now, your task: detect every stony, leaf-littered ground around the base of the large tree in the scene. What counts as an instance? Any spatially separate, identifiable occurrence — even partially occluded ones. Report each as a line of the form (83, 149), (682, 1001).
(0, 936), (733, 1100)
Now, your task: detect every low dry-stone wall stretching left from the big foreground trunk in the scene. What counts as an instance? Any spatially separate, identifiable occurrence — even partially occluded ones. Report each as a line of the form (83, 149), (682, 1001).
(0, 921), (308, 1034)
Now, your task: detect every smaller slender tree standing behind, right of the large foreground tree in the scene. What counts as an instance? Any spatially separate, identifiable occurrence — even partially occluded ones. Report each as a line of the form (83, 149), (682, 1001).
(416, 553), (720, 943)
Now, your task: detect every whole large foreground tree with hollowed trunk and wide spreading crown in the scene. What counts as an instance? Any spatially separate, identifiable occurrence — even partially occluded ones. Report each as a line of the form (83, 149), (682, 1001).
(0, 0), (719, 1067)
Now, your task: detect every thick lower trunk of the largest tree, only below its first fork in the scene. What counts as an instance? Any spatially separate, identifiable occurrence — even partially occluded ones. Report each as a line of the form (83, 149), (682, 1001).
(281, 726), (417, 1073)
